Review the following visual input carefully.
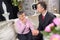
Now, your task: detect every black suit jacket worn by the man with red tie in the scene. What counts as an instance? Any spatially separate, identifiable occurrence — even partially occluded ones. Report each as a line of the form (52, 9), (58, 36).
(38, 12), (56, 31)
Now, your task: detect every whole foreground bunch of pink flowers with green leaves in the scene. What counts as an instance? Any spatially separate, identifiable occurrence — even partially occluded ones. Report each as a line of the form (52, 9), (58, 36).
(42, 18), (60, 40)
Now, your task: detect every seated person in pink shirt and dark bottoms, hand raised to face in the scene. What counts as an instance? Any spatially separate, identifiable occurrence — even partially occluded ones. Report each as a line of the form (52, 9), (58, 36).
(15, 11), (39, 40)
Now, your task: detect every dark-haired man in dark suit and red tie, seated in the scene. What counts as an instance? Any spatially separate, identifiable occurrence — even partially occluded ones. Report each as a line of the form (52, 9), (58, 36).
(34, 2), (56, 40)
